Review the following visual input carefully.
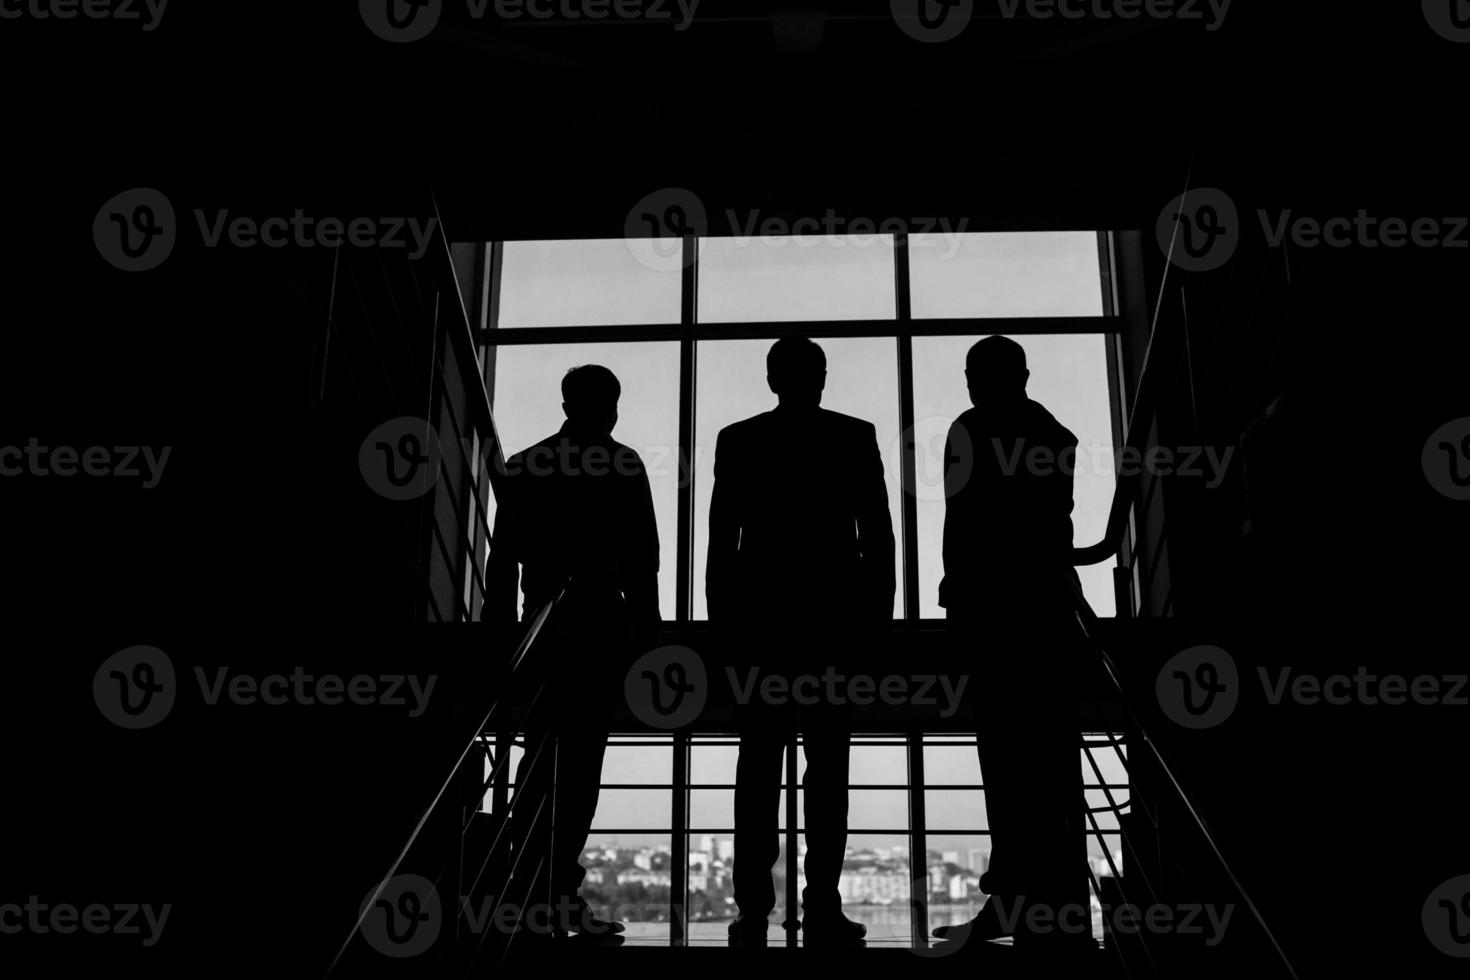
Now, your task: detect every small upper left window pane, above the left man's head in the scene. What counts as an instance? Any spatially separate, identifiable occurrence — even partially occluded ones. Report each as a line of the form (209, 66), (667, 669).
(498, 238), (682, 328)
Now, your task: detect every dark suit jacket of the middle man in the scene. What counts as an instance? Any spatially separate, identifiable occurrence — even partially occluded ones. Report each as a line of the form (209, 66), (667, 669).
(706, 407), (895, 623)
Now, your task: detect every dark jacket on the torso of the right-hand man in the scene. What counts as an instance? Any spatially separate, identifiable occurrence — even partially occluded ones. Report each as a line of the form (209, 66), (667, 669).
(939, 398), (1078, 613)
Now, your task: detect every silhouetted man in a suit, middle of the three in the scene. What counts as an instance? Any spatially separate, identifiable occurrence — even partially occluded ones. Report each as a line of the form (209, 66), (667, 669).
(706, 338), (894, 945)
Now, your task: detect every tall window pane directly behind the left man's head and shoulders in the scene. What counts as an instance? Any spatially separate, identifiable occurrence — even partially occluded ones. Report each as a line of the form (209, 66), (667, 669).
(491, 342), (679, 620)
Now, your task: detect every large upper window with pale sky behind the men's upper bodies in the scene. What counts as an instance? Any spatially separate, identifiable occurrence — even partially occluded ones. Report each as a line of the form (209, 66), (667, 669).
(478, 232), (1119, 621)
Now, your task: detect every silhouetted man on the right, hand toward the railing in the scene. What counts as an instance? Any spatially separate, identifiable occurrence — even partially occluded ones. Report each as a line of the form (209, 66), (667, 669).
(935, 336), (1092, 945)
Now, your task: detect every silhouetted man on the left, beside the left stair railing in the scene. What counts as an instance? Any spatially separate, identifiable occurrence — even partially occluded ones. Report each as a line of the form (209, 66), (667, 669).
(485, 364), (660, 933)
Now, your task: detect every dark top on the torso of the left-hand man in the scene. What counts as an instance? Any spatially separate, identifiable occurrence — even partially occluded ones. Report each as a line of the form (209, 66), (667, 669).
(485, 425), (659, 627)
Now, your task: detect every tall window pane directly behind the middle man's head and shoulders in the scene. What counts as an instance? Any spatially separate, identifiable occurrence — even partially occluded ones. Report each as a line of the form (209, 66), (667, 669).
(694, 336), (903, 619)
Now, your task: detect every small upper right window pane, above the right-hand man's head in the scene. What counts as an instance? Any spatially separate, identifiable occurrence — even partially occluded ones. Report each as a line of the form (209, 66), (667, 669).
(908, 231), (1103, 319)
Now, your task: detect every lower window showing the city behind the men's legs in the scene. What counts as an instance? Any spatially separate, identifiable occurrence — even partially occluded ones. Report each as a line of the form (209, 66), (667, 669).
(485, 733), (1130, 948)
